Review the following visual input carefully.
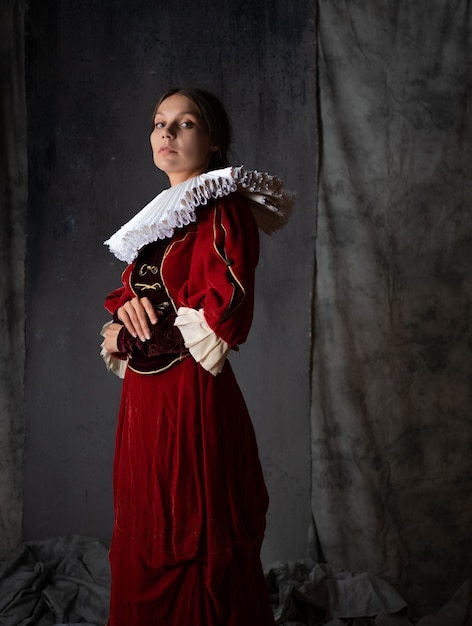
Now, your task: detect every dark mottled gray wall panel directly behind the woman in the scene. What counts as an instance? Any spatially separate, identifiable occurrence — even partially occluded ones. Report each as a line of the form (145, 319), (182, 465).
(25, 0), (316, 563)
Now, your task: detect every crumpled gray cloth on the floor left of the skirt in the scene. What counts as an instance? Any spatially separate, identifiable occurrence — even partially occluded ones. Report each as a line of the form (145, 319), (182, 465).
(0, 535), (110, 626)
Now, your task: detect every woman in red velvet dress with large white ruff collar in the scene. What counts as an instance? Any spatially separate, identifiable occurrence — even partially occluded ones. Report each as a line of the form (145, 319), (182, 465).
(102, 89), (293, 626)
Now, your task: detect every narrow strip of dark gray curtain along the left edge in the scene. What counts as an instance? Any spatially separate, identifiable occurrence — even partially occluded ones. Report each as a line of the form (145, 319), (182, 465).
(0, 0), (27, 559)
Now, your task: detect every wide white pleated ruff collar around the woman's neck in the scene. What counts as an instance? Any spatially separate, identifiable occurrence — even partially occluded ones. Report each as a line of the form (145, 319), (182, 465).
(105, 167), (294, 263)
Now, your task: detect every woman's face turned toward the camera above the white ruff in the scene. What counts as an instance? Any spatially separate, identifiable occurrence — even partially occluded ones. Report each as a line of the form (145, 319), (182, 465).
(151, 94), (218, 186)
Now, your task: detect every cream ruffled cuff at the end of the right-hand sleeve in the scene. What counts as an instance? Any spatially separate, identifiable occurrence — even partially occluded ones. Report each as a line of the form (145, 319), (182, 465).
(175, 306), (230, 376)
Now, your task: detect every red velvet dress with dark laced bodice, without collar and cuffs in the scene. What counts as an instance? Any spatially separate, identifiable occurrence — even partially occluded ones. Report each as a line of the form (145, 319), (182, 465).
(102, 193), (274, 626)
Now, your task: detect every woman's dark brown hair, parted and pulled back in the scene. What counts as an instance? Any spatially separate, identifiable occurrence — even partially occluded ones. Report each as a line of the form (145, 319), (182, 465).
(151, 87), (231, 171)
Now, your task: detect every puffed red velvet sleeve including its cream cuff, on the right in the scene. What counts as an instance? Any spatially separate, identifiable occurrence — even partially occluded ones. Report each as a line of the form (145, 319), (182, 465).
(175, 193), (259, 374)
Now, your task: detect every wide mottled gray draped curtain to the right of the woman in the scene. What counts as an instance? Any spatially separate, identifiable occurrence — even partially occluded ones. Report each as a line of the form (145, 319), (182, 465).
(311, 0), (472, 606)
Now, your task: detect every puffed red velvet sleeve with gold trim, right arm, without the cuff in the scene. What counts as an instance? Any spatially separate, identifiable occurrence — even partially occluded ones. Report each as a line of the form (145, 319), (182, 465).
(181, 193), (259, 347)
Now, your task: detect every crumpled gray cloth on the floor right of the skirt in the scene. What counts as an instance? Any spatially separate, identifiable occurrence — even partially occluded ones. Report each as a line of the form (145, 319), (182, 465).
(265, 559), (472, 626)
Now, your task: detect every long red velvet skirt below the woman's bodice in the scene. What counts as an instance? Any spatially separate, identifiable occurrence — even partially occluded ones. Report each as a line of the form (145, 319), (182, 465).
(109, 357), (274, 626)
